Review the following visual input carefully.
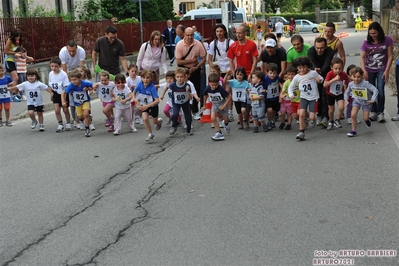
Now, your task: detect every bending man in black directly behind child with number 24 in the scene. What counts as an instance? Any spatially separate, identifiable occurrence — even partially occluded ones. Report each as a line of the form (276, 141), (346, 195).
(308, 37), (335, 127)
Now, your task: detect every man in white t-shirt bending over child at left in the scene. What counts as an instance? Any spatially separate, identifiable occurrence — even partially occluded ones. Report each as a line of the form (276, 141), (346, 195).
(58, 40), (86, 72)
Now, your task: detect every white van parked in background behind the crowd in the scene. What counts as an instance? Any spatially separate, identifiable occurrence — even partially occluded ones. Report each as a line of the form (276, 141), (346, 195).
(180, 7), (247, 27)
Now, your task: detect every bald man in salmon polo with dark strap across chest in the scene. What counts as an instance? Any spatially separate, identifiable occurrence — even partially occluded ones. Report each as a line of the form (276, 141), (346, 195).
(175, 25), (206, 120)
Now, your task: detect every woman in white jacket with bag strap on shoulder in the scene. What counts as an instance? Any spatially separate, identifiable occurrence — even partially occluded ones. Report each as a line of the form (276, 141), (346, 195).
(137, 30), (168, 84)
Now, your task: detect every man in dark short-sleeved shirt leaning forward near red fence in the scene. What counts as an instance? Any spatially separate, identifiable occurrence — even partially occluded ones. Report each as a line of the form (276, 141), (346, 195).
(91, 26), (128, 75)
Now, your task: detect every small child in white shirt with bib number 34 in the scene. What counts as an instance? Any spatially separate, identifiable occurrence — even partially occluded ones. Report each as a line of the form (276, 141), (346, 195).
(93, 71), (115, 132)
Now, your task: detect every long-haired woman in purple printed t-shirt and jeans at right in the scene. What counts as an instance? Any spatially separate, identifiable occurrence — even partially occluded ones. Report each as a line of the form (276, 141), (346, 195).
(360, 22), (393, 123)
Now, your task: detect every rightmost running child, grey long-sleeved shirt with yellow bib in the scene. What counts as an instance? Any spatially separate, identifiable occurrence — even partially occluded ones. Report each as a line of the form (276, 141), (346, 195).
(344, 67), (378, 137)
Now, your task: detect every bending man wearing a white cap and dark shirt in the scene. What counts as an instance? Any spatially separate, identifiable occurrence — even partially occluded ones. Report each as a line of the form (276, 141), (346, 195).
(258, 38), (287, 80)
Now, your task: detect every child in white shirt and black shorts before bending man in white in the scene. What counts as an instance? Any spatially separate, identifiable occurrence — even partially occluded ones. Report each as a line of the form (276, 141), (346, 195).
(48, 57), (71, 133)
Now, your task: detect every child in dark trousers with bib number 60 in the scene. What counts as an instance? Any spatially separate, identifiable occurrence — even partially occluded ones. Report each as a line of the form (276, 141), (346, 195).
(169, 67), (193, 135)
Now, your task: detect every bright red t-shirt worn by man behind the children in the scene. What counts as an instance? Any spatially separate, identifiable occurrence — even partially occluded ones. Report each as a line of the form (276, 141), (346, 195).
(227, 40), (258, 75)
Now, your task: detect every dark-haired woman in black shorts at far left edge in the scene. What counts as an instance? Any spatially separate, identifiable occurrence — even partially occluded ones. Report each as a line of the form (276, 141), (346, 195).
(4, 29), (23, 102)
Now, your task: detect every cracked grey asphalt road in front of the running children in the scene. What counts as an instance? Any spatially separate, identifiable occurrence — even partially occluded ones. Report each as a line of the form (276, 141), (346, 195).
(0, 28), (399, 266)
